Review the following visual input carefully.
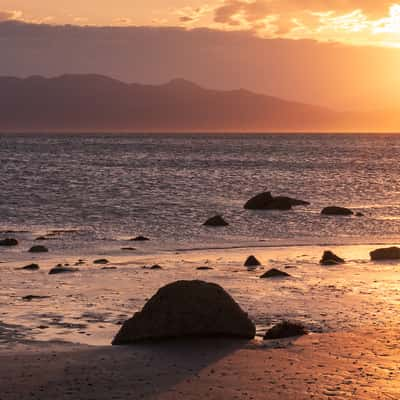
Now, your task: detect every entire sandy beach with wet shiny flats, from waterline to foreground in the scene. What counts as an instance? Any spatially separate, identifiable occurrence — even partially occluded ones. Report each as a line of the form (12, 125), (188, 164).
(0, 245), (400, 400)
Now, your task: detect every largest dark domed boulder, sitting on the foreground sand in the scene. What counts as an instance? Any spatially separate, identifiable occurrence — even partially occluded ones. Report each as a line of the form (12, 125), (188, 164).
(113, 281), (256, 345)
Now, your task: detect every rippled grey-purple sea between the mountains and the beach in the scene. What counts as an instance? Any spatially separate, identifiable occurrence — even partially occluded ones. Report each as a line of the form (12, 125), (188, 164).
(0, 134), (400, 250)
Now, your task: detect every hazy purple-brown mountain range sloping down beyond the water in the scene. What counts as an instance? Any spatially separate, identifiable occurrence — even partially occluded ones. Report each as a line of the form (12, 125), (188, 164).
(0, 75), (400, 132)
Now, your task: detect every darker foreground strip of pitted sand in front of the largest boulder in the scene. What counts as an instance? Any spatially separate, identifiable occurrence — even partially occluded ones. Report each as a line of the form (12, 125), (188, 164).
(0, 330), (400, 400)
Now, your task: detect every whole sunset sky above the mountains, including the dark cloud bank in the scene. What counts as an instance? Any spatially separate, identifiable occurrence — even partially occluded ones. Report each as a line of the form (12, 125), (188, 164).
(0, 0), (400, 110)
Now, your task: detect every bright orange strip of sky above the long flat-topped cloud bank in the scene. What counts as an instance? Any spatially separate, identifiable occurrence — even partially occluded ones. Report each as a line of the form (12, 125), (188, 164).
(0, 0), (400, 47)
